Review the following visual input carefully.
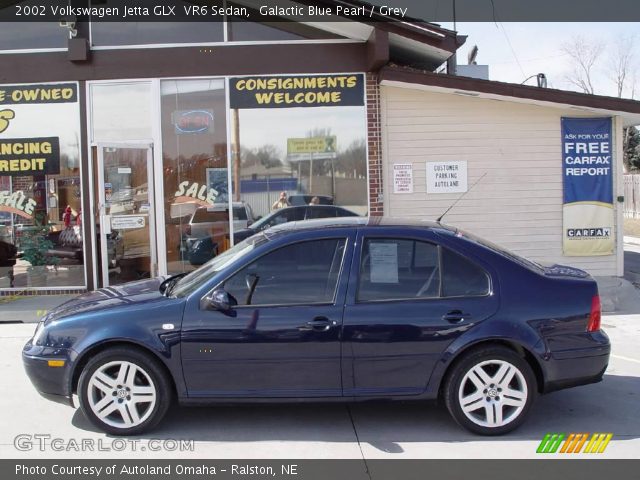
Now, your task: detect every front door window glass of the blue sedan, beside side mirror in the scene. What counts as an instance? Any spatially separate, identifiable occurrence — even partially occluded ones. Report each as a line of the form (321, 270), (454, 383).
(224, 239), (346, 306)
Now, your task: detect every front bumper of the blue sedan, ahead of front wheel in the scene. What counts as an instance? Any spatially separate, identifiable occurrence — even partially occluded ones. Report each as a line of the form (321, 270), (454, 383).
(22, 342), (76, 406)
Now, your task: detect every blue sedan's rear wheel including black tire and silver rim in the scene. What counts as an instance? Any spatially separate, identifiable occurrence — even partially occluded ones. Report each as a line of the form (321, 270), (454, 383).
(443, 346), (537, 435)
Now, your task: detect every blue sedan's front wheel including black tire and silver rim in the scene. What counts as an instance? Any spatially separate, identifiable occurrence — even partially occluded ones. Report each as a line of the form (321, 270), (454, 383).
(78, 347), (173, 435)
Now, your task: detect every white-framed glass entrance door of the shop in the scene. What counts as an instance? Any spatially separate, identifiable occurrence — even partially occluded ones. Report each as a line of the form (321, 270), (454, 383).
(96, 143), (157, 287)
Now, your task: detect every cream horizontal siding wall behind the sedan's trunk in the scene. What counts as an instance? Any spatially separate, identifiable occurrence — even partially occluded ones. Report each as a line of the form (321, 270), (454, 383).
(381, 86), (622, 275)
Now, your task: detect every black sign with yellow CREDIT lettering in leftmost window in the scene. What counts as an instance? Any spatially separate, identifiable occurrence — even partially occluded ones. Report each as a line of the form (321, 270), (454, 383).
(0, 137), (60, 176)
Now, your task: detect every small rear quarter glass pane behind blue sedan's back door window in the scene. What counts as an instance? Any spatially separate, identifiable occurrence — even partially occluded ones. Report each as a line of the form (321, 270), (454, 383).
(442, 248), (489, 297)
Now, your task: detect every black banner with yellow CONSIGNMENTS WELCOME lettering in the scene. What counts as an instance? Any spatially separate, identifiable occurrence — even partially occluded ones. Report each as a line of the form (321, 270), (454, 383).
(229, 74), (364, 108)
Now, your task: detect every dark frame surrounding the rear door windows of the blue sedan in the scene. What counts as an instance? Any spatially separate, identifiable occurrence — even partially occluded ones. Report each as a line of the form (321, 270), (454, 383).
(354, 234), (494, 304)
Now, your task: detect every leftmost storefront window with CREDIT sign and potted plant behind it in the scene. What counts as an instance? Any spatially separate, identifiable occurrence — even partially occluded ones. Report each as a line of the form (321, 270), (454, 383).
(0, 83), (85, 289)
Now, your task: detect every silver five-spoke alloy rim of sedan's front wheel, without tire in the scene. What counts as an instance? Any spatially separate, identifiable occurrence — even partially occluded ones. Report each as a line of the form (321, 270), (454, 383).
(87, 361), (157, 429)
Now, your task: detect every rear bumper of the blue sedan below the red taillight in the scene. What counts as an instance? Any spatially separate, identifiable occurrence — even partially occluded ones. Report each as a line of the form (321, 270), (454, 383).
(543, 331), (611, 393)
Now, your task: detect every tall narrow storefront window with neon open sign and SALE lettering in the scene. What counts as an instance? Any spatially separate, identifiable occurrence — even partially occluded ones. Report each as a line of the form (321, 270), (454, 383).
(161, 79), (228, 273)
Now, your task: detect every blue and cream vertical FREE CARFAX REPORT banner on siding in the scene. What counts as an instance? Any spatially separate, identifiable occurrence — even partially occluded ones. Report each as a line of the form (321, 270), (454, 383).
(562, 117), (614, 256)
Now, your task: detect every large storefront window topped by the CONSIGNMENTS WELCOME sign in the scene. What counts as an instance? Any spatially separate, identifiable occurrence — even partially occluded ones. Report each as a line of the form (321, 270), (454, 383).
(230, 74), (368, 232)
